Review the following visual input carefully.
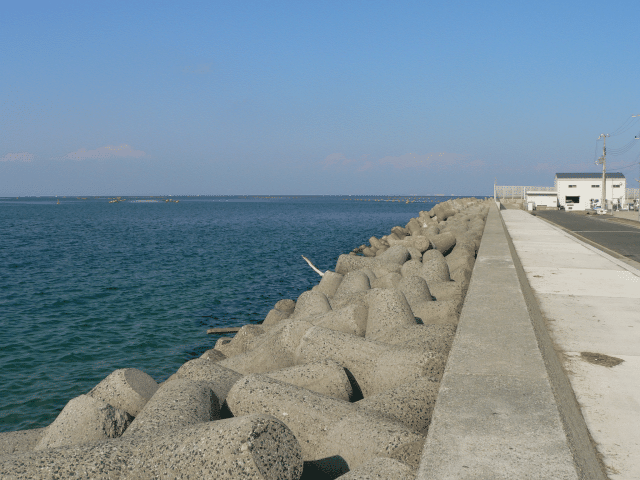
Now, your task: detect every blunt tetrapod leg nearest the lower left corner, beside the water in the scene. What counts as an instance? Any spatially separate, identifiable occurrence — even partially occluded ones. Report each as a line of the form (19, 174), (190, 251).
(34, 395), (133, 450)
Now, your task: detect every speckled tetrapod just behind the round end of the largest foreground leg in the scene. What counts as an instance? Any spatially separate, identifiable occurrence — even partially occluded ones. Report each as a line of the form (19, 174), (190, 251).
(227, 375), (424, 467)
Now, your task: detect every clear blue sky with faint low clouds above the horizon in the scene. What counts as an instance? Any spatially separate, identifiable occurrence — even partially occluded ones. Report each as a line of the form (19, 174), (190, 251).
(0, 0), (640, 197)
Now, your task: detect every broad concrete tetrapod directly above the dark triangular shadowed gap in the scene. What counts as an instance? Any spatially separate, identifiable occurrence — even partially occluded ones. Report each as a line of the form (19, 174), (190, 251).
(296, 327), (446, 398)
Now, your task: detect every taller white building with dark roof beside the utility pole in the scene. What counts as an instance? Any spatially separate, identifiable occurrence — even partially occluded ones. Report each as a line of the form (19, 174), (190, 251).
(555, 173), (627, 210)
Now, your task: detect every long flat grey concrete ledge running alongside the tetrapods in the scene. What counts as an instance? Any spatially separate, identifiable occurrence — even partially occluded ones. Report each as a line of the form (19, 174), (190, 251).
(417, 204), (592, 480)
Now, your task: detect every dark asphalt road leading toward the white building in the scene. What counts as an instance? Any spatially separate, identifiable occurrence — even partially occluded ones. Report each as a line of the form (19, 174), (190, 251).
(536, 210), (640, 262)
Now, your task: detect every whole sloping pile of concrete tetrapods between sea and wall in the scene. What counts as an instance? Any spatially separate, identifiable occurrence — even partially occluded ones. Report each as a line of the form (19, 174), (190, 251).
(0, 199), (489, 478)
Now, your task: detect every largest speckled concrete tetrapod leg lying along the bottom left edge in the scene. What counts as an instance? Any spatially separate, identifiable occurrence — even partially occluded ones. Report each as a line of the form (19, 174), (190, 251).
(0, 415), (303, 480)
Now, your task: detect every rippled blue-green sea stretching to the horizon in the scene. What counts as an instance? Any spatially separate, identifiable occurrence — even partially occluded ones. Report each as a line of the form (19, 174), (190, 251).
(0, 196), (470, 431)
